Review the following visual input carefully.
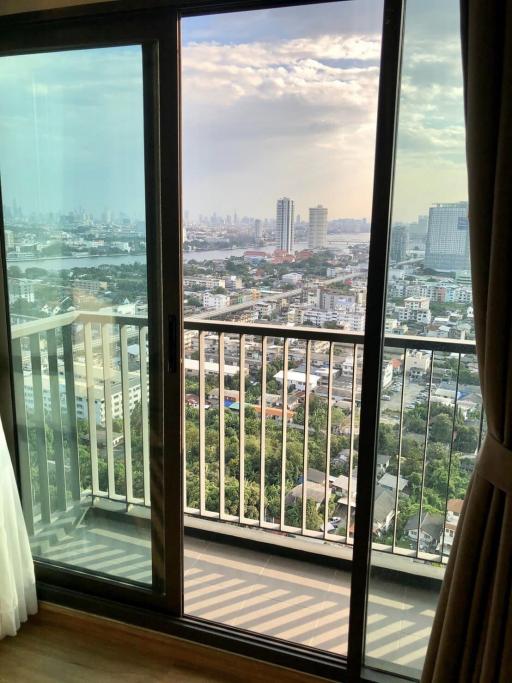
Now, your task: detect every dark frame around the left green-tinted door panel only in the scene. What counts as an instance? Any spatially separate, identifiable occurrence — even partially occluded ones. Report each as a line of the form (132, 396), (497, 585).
(0, 3), (183, 616)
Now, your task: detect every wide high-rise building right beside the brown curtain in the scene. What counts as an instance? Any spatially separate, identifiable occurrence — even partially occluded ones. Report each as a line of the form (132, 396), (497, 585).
(425, 202), (470, 272)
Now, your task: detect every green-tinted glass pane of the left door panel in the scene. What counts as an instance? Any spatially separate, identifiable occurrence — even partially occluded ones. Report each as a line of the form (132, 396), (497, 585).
(0, 46), (151, 583)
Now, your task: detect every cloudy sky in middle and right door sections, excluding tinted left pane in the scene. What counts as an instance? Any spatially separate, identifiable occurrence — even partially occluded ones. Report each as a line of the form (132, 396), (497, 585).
(183, 0), (465, 220)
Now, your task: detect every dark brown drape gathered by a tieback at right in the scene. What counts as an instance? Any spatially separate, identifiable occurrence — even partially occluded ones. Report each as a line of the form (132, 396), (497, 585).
(422, 0), (512, 683)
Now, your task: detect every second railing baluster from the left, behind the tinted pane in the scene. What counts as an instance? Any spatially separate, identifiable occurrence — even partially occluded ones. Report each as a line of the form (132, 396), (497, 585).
(30, 333), (51, 523)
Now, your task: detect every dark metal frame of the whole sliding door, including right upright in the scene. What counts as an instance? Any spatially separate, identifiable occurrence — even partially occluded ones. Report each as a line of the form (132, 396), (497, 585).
(0, 0), (405, 681)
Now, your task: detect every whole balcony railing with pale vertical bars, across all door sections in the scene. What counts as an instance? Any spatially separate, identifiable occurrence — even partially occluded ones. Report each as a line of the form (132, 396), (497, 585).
(12, 312), (484, 562)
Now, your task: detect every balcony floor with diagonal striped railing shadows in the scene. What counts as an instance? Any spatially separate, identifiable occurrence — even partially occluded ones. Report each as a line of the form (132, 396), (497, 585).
(33, 515), (437, 671)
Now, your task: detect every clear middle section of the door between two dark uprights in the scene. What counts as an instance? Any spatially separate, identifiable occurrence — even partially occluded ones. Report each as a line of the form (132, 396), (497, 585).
(182, 0), (382, 654)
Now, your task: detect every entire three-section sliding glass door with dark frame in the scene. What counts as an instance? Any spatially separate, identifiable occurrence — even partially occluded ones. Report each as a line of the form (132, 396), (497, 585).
(0, 0), (472, 680)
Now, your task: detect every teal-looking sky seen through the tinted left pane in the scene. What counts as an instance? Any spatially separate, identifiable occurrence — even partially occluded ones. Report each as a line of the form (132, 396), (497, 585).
(0, 47), (144, 218)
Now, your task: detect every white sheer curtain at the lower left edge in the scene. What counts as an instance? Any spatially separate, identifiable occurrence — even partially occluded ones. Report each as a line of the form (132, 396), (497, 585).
(0, 421), (37, 639)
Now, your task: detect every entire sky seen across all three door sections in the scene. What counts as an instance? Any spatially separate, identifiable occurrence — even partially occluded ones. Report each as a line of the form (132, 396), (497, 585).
(0, 0), (467, 220)
